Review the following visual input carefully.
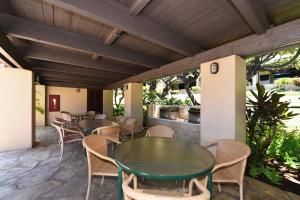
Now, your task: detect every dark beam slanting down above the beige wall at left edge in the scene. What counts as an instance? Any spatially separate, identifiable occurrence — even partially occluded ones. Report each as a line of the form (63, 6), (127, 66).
(0, 31), (30, 69)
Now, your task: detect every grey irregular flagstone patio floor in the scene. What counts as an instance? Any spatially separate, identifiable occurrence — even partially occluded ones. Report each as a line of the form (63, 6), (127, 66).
(0, 127), (300, 200)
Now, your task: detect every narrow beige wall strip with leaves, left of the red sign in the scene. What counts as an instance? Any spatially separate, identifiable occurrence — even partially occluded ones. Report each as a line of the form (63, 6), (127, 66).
(35, 85), (46, 126)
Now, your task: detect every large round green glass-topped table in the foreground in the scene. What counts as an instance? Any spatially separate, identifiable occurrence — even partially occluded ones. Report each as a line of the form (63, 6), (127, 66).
(114, 137), (215, 200)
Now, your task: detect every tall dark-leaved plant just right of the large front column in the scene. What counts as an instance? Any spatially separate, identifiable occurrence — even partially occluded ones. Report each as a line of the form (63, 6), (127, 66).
(246, 83), (296, 182)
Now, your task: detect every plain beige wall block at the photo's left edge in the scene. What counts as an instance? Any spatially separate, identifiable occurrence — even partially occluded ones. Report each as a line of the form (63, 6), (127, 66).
(0, 68), (35, 152)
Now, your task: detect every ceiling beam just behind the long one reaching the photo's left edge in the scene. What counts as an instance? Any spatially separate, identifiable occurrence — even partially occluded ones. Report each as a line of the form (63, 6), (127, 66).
(20, 45), (146, 77)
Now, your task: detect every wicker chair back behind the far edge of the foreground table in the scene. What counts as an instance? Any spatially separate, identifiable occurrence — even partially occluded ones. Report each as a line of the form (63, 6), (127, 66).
(146, 125), (176, 138)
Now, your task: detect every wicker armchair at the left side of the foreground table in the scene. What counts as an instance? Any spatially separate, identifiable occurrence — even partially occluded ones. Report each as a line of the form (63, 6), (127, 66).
(83, 135), (119, 200)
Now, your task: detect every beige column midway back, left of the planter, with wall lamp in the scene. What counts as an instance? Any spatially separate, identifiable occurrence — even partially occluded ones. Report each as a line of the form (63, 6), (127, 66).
(124, 83), (143, 132)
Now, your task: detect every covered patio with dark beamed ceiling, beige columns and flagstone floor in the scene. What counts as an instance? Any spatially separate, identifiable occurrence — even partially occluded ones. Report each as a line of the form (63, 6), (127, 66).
(0, 0), (300, 200)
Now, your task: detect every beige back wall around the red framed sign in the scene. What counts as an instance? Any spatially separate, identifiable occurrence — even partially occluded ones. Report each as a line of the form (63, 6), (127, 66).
(46, 86), (87, 125)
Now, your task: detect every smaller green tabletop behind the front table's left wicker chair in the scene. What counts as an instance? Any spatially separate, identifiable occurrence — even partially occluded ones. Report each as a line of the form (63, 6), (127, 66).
(78, 119), (119, 134)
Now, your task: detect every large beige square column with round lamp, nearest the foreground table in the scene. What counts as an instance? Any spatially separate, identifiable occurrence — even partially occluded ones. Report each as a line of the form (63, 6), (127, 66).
(201, 55), (246, 144)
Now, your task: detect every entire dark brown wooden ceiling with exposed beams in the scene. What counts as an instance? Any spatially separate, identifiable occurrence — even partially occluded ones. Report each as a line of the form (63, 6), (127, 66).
(0, 0), (300, 88)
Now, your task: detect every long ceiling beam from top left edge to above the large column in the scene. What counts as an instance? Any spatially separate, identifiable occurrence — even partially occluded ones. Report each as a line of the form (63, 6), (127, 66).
(44, 0), (200, 56)
